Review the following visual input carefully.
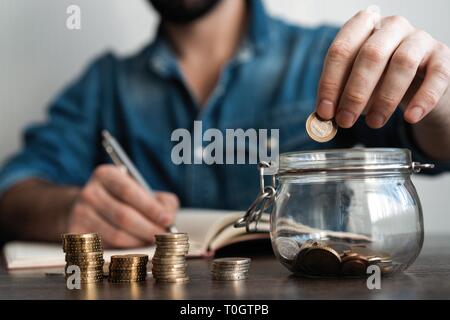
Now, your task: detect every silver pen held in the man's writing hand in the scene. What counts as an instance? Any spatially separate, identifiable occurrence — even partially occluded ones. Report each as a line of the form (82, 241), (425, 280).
(102, 130), (178, 233)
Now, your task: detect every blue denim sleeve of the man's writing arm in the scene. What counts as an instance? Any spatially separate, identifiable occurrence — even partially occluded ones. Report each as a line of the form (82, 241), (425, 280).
(0, 56), (114, 196)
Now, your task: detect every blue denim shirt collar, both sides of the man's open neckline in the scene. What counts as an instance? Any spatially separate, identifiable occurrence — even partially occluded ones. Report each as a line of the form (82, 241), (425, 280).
(147, 0), (271, 76)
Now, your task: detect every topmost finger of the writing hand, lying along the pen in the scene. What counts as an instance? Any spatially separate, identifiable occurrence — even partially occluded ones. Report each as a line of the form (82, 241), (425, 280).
(94, 165), (170, 226)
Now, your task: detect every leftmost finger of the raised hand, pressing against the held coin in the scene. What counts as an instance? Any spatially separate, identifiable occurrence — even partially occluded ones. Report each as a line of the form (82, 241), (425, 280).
(316, 11), (380, 120)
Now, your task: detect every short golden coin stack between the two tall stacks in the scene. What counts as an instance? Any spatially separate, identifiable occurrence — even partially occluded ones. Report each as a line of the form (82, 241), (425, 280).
(109, 254), (148, 282)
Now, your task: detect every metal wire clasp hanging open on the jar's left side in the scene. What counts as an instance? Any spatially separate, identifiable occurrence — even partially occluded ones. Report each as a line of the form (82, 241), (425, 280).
(234, 161), (276, 233)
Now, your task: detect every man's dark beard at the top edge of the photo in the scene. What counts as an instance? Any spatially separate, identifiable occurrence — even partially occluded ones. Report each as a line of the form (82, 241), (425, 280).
(148, 0), (221, 24)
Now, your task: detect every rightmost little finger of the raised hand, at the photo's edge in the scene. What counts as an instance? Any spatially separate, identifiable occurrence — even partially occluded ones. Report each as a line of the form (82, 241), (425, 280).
(404, 43), (450, 124)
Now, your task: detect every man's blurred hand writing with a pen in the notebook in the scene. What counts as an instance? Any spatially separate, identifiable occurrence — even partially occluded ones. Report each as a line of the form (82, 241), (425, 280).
(68, 165), (179, 247)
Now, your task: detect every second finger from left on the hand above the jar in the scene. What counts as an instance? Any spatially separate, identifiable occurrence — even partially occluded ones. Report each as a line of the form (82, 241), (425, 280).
(336, 17), (414, 128)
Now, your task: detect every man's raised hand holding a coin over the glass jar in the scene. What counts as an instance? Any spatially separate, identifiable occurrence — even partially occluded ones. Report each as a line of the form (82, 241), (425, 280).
(317, 11), (450, 128)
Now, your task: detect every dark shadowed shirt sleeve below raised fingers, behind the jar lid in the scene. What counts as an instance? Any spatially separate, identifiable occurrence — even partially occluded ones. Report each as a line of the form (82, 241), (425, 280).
(336, 109), (450, 175)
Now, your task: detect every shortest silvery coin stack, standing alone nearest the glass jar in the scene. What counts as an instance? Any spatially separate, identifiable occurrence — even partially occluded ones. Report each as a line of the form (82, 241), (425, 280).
(211, 258), (251, 281)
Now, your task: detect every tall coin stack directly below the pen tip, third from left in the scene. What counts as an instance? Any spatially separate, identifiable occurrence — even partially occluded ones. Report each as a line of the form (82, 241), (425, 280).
(152, 233), (189, 283)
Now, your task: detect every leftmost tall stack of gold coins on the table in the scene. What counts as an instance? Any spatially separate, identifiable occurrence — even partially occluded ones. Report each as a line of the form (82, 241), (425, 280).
(62, 233), (104, 283)
